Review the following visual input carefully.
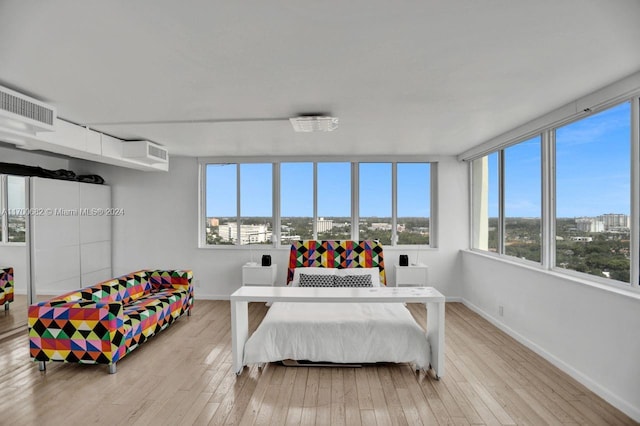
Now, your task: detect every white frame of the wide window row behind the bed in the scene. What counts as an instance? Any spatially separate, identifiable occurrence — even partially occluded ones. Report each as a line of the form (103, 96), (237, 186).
(198, 157), (438, 249)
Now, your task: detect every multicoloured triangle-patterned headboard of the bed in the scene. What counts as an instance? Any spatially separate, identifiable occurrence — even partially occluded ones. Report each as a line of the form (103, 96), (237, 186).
(287, 240), (387, 285)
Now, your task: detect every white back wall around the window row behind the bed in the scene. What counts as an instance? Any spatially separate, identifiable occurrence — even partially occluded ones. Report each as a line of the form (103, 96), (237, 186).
(72, 157), (468, 298)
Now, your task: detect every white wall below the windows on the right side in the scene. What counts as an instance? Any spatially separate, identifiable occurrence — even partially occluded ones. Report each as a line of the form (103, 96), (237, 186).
(462, 251), (640, 421)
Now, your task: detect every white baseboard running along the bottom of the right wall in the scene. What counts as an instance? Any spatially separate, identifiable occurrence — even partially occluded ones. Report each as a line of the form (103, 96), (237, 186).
(460, 298), (640, 422)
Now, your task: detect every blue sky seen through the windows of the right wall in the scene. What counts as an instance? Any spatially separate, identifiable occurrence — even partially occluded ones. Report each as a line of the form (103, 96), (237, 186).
(489, 102), (631, 217)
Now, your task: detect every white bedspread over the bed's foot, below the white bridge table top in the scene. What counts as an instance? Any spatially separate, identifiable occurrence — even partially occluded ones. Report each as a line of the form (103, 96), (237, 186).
(244, 302), (431, 369)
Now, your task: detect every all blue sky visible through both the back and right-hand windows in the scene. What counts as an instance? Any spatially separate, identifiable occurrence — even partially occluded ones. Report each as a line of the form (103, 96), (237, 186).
(206, 102), (631, 217)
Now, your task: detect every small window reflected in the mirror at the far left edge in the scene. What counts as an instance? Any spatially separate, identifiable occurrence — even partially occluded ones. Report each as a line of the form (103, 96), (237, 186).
(0, 176), (27, 243)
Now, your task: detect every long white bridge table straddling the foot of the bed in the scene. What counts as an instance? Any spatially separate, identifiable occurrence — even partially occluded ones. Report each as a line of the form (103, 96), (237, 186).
(230, 286), (445, 379)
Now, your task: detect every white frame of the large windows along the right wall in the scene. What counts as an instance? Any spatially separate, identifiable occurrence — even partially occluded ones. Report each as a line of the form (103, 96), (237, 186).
(462, 94), (640, 293)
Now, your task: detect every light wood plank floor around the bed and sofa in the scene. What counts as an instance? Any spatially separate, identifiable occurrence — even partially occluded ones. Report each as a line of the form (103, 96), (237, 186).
(0, 301), (634, 425)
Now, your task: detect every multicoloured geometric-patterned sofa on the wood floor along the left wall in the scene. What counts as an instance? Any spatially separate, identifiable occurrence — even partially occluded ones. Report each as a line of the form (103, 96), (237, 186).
(29, 270), (193, 374)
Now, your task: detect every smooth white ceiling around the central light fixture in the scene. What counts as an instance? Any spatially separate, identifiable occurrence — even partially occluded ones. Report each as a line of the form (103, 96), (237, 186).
(0, 0), (640, 156)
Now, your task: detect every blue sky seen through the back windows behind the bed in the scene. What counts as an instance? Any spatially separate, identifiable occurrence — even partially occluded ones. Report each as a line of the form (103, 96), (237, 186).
(206, 162), (430, 217)
